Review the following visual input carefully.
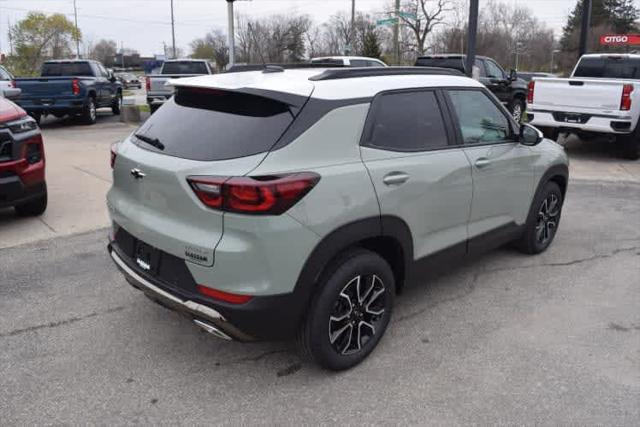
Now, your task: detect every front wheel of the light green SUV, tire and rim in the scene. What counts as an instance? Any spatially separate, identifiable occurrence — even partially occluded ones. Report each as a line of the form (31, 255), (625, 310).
(517, 181), (564, 255)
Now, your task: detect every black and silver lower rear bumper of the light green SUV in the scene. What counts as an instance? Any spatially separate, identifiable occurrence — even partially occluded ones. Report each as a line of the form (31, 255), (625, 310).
(108, 242), (304, 341)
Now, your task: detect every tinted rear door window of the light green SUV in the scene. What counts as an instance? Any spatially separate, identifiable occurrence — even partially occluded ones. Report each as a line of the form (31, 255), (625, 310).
(365, 91), (448, 151)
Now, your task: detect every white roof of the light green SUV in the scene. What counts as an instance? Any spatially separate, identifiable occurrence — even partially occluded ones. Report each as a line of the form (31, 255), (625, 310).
(169, 68), (483, 100)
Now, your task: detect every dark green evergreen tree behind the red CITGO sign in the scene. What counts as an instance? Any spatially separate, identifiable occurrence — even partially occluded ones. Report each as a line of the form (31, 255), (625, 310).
(560, 0), (640, 68)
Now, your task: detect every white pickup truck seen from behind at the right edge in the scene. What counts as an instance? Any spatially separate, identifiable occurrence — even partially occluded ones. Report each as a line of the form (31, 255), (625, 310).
(527, 54), (640, 160)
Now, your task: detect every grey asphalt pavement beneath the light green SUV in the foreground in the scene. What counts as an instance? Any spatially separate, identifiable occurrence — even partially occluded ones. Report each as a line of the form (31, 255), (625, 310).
(0, 181), (640, 425)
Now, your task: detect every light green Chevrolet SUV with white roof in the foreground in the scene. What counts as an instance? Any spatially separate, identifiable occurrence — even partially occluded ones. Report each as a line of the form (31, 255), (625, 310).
(107, 67), (568, 370)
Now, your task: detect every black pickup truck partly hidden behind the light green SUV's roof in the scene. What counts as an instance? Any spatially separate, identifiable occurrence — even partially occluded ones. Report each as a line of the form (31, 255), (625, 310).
(416, 54), (527, 122)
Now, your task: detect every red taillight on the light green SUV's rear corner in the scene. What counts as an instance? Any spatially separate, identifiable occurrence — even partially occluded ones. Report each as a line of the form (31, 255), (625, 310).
(187, 172), (320, 215)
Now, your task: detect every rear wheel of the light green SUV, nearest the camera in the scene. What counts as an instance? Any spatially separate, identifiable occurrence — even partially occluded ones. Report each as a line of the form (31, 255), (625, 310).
(298, 249), (395, 371)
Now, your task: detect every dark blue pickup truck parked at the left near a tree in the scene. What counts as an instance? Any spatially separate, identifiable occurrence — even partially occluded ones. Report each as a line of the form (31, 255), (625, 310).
(16, 60), (122, 124)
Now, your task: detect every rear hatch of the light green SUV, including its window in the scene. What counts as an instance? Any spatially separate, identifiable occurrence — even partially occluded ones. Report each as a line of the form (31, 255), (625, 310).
(108, 83), (310, 266)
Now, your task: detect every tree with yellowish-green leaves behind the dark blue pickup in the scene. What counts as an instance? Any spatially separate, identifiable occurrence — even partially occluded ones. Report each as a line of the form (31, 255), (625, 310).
(8, 12), (82, 75)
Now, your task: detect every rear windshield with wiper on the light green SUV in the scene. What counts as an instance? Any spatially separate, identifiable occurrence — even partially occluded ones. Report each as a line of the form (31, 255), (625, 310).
(133, 88), (294, 161)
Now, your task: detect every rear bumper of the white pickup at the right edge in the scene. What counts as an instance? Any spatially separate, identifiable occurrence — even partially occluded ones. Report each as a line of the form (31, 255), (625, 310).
(528, 106), (637, 134)
